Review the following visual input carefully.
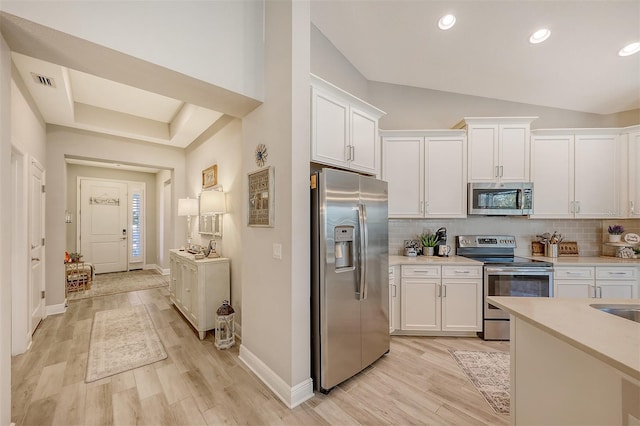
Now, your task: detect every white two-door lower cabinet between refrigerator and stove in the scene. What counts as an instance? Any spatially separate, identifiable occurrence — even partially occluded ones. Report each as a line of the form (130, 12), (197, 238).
(400, 265), (482, 332)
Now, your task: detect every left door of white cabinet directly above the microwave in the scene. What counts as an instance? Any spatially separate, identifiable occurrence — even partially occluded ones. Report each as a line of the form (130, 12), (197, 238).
(468, 124), (500, 182)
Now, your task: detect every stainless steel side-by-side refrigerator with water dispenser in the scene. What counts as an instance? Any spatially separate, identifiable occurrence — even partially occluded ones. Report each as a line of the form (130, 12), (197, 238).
(311, 169), (389, 393)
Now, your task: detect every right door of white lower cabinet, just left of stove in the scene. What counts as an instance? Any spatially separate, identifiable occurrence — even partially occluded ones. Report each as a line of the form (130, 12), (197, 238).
(442, 279), (482, 331)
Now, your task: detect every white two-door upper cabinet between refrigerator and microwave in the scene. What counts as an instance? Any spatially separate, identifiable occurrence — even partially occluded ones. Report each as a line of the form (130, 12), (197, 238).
(380, 130), (467, 218)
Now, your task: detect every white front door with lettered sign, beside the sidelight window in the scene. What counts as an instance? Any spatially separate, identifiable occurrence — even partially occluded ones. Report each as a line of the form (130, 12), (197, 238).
(80, 179), (128, 273)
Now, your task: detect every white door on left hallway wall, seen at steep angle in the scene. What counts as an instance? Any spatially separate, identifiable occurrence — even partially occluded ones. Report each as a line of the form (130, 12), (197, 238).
(29, 160), (45, 334)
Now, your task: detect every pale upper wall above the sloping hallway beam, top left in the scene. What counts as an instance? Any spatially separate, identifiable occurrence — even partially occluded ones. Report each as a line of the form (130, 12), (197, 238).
(1, 0), (263, 99)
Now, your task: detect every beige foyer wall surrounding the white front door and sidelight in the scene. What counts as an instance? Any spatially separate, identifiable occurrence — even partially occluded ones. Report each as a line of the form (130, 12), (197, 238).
(65, 164), (161, 265)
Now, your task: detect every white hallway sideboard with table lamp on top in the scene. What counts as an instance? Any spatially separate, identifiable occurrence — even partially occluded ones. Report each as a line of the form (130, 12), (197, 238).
(169, 250), (231, 340)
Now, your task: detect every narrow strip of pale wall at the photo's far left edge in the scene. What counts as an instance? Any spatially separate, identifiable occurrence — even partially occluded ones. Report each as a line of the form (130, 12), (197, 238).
(0, 32), (11, 425)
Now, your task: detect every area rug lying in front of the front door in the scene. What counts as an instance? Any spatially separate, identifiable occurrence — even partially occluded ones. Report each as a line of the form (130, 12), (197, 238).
(67, 269), (169, 302)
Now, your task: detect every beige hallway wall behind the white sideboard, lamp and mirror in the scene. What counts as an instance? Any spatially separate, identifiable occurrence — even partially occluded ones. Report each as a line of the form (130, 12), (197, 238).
(186, 119), (246, 334)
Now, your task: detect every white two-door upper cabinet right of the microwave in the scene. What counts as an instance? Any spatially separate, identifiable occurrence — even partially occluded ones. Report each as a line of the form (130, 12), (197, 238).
(531, 129), (627, 219)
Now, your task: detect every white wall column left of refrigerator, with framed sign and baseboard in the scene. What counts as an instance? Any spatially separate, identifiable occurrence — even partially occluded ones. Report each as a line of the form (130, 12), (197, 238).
(240, 0), (312, 405)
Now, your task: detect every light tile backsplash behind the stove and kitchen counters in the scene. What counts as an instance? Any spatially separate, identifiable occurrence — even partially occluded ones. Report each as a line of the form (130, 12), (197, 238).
(389, 217), (640, 256)
